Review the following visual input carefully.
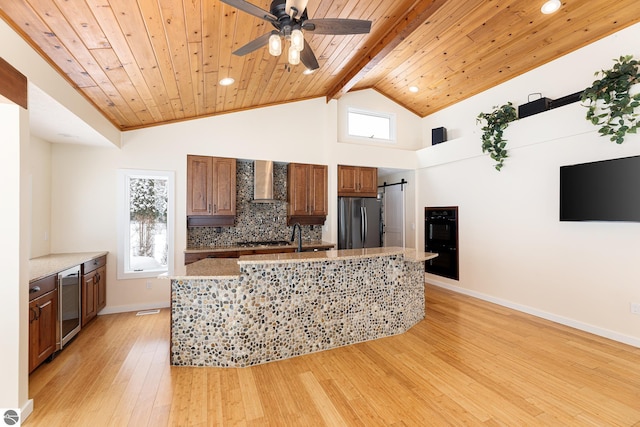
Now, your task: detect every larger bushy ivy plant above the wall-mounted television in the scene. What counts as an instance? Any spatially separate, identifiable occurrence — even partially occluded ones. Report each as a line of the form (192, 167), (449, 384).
(582, 55), (640, 144)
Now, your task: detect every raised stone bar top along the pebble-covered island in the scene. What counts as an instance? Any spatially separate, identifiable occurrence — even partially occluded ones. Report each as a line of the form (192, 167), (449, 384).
(238, 247), (437, 266)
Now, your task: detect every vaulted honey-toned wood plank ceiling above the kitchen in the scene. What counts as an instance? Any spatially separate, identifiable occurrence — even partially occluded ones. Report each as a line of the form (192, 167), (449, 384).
(0, 0), (640, 130)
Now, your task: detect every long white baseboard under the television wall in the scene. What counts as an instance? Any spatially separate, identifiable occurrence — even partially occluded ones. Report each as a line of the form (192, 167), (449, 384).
(425, 277), (640, 348)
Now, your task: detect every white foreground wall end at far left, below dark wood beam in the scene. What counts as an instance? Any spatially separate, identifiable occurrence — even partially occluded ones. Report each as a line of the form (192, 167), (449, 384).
(0, 103), (33, 416)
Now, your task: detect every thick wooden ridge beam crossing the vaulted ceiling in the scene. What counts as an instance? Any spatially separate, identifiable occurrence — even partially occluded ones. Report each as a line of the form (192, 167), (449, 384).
(327, 0), (446, 102)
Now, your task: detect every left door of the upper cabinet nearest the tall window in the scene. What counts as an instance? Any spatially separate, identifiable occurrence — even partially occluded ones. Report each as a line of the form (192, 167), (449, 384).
(187, 156), (213, 215)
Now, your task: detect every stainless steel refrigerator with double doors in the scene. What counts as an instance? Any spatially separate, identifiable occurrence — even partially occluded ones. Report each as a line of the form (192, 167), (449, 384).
(338, 197), (382, 249)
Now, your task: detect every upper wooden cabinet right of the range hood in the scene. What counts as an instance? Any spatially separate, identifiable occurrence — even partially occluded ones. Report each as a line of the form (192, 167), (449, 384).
(287, 163), (328, 225)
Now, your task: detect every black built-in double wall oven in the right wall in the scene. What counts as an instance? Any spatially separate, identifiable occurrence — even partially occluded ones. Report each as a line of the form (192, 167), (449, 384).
(424, 206), (459, 280)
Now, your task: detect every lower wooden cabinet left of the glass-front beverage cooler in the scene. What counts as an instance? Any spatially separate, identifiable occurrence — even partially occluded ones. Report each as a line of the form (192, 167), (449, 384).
(29, 275), (58, 373)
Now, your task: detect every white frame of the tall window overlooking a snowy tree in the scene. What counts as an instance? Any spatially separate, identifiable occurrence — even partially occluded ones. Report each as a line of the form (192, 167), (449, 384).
(117, 169), (175, 280)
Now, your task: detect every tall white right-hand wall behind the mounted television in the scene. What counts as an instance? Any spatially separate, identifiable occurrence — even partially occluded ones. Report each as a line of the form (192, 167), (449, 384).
(418, 25), (640, 346)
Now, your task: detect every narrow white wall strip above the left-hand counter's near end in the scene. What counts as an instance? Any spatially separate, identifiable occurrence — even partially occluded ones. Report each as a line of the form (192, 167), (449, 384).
(29, 135), (51, 258)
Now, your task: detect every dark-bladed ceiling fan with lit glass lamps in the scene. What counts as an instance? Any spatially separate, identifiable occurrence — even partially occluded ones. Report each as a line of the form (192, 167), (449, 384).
(220, 0), (371, 71)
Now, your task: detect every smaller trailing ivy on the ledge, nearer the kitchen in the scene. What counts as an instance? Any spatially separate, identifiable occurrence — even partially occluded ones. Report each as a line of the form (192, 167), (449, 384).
(476, 102), (518, 171)
